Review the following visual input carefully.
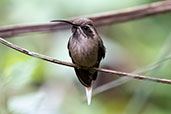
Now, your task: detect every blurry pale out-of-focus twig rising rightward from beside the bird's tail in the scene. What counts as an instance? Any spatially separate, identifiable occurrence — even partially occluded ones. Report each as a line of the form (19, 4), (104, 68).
(93, 33), (171, 96)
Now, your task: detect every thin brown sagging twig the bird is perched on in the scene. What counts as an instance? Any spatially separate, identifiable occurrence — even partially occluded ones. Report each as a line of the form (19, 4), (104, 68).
(0, 38), (171, 84)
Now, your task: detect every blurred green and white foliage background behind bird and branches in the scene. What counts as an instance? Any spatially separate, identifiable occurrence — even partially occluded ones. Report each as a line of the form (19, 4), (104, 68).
(0, 0), (171, 114)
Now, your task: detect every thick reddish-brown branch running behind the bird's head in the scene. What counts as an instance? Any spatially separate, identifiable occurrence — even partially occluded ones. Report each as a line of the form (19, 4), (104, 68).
(0, 0), (171, 38)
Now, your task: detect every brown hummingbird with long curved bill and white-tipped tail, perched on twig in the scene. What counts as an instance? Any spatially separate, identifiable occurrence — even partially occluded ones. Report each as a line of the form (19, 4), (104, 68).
(51, 18), (106, 105)
